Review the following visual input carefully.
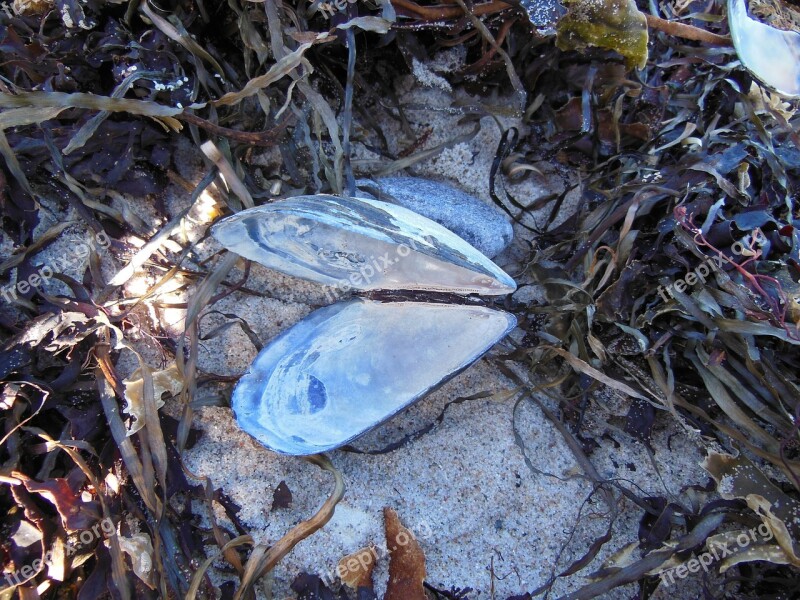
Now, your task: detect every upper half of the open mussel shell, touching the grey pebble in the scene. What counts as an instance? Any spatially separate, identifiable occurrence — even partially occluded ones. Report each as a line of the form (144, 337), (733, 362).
(212, 194), (516, 295)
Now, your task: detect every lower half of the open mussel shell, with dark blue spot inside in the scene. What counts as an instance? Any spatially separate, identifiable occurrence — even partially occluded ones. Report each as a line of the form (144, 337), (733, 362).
(232, 298), (516, 455)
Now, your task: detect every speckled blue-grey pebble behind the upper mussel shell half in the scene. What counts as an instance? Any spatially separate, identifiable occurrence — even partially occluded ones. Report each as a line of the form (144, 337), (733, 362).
(356, 177), (514, 258)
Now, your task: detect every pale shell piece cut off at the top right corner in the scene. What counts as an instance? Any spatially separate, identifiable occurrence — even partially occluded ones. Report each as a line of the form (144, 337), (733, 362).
(728, 0), (800, 98)
